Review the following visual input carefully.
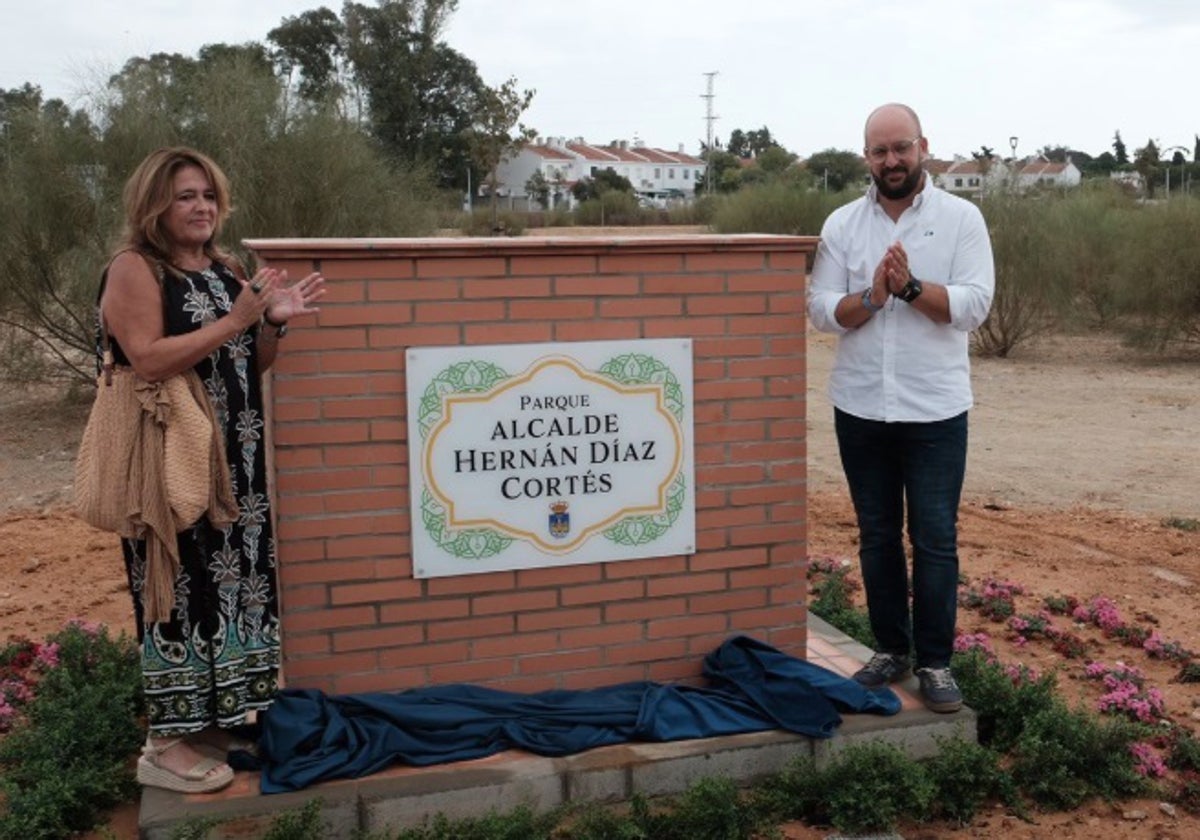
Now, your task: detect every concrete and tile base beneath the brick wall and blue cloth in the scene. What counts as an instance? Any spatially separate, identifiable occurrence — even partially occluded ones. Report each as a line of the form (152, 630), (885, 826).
(139, 616), (976, 840)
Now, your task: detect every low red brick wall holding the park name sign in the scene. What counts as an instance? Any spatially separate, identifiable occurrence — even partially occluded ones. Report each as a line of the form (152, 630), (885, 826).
(247, 235), (816, 694)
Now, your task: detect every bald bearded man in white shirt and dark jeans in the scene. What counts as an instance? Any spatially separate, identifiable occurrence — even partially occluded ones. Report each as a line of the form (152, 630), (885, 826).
(808, 103), (995, 712)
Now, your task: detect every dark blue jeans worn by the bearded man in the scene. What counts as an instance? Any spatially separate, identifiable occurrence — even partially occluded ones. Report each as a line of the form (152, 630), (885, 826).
(834, 409), (967, 667)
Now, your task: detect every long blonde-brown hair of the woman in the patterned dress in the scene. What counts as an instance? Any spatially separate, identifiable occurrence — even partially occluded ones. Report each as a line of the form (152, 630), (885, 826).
(118, 146), (233, 263)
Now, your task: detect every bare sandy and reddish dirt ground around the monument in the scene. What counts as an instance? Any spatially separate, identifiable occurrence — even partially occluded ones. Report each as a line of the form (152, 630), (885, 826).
(0, 335), (1200, 840)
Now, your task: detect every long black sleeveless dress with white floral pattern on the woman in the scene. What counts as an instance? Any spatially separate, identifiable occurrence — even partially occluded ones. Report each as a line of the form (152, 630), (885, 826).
(114, 263), (280, 737)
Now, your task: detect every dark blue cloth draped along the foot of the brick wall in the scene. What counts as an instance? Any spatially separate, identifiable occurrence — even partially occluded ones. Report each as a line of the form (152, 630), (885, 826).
(260, 636), (900, 793)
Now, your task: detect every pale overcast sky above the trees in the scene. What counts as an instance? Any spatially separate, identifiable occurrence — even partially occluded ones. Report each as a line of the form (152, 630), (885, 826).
(0, 0), (1200, 160)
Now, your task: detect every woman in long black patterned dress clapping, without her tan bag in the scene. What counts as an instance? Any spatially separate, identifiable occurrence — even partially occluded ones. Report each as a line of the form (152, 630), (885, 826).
(100, 148), (324, 793)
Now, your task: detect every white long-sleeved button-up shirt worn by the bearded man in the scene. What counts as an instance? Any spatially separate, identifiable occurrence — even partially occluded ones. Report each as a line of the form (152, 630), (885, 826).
(808, 181), (996, 422)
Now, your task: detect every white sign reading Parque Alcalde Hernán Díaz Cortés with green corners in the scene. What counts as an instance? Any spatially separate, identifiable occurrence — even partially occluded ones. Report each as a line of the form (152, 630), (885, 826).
(407, 338), (696, 577)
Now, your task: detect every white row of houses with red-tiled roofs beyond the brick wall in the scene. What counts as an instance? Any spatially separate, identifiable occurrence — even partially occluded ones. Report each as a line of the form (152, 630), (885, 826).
(496, 137), (707, 210)
